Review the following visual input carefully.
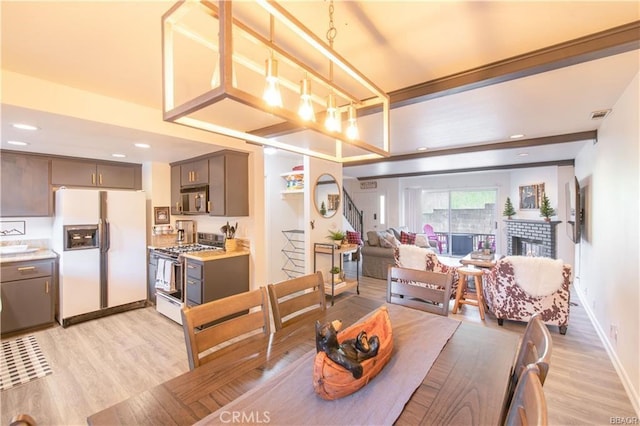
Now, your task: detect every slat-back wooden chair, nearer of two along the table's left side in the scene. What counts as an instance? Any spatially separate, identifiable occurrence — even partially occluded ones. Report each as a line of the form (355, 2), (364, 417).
(182, 287), (271, 370)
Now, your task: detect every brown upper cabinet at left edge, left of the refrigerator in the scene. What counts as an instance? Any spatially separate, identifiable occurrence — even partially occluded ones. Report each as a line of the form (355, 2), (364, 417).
(0, 151), (53, 217)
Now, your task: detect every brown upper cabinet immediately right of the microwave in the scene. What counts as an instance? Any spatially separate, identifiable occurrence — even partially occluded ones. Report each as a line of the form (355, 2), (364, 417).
(209, 151), (249, 216)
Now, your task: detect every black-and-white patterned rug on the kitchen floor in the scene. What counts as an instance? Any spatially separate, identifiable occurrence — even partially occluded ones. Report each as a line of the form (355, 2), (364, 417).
(0, 335), (53, 390)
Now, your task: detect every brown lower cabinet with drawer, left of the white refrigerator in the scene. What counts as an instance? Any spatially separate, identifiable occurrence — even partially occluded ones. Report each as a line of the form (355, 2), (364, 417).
(0, 259), (56, 334)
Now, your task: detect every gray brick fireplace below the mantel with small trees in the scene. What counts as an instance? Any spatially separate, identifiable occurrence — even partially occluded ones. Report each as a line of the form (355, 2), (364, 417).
(505, 219), (561, 259)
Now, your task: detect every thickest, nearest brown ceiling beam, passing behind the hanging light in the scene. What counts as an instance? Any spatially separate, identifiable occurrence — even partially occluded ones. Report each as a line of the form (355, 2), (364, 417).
(249, 21), (640, 138)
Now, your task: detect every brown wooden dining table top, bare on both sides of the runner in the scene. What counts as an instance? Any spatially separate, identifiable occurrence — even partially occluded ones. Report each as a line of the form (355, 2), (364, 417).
(87, 295), (518, 425)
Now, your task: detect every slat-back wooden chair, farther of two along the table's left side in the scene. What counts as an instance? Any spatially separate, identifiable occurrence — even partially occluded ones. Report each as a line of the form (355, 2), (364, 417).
(268, 271), (327, 330)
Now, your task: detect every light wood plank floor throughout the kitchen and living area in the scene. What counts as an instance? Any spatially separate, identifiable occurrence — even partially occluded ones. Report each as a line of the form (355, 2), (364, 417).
(0, 270), (637, 425)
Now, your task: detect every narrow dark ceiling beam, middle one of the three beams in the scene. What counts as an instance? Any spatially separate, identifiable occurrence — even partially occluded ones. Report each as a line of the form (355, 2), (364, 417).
(342, 130), (598, 167)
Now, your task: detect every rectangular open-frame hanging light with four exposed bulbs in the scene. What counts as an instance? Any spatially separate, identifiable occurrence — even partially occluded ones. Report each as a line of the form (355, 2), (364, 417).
(162, 0), (390, 162)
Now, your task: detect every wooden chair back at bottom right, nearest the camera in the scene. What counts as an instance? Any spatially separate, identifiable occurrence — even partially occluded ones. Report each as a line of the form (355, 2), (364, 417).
(504, 364), (548, 426)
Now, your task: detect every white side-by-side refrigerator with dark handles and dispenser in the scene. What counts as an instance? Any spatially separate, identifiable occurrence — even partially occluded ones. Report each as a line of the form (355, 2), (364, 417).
(52, 188), (147, 326)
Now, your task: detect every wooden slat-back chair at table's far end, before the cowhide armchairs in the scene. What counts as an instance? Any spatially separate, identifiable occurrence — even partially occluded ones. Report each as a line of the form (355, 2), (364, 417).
(387, 266), (453, 316)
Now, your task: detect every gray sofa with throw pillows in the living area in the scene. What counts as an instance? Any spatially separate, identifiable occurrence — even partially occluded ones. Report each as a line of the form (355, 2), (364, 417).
(361, 227), (436, 280)
